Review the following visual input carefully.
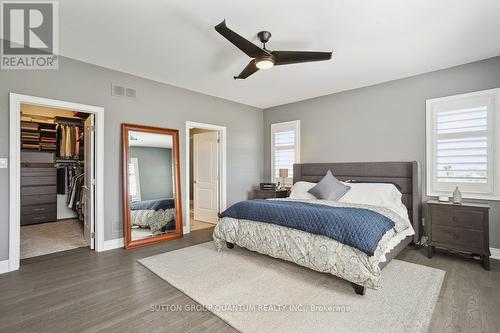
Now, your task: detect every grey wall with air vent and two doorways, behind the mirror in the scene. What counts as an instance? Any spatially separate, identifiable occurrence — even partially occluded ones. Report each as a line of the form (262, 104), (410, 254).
(0, 57), (264, 260)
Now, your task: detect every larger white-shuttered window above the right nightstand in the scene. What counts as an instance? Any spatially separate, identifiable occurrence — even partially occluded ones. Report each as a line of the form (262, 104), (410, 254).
(426, 89), (500, 200)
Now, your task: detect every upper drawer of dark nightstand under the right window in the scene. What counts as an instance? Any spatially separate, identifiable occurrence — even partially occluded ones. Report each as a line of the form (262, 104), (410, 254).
(431, 206), (484, 231)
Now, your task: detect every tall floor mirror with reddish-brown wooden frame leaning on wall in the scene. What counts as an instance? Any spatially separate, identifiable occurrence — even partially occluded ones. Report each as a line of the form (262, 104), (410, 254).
(122, 124), (182, 249)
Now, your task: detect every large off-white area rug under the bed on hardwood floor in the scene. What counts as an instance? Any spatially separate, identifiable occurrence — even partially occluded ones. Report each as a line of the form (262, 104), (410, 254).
(140, 242), (445, 332)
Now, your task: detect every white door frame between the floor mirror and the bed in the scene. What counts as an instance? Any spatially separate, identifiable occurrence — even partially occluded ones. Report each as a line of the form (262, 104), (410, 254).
(184, 121), (227, 234)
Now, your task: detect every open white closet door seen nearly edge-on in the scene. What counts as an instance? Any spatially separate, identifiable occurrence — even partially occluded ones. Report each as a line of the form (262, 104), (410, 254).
(83, 114), (95, 249)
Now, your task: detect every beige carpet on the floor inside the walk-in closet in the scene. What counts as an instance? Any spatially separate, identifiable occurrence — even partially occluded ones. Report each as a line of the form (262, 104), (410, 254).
(21, 220), (87, 259)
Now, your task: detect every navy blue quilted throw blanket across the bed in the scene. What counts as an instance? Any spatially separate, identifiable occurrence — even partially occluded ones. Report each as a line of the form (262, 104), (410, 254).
(219, 199), (395, 256)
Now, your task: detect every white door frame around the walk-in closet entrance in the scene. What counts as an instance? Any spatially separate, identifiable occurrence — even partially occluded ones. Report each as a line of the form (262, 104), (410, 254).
(8, 93), (105, 272)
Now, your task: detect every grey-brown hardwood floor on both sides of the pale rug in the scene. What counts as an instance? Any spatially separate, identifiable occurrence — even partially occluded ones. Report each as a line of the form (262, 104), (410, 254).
(0, 228), (500, 333)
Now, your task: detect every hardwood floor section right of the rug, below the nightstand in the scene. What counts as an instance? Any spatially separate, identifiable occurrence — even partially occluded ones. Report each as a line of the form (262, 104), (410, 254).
(398, 248), (500, 333)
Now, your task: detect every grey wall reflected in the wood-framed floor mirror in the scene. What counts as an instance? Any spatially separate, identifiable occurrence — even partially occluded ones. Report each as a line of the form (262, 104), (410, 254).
(129, 147), (174, 200)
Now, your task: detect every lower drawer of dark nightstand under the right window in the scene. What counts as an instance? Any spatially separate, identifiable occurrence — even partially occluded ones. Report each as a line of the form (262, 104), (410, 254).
(432, 225), (484, 248)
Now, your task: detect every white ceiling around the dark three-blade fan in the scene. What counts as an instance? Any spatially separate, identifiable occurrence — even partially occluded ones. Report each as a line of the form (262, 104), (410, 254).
(59, 0), (500, 108)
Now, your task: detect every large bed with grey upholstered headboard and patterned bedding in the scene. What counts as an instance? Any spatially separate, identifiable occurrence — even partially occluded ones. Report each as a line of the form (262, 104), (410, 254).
(213, 162), (422, 295)
